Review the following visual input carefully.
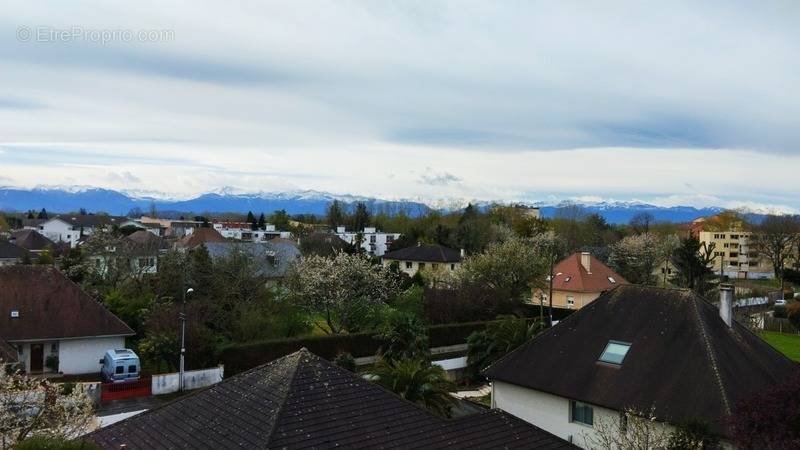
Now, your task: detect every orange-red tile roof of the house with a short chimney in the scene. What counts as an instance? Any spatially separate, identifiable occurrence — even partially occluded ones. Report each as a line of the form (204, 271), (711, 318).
(553, 252), (630, 292)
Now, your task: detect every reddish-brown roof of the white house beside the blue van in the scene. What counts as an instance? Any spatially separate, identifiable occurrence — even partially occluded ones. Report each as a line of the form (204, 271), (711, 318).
(0, 266), (134, 342)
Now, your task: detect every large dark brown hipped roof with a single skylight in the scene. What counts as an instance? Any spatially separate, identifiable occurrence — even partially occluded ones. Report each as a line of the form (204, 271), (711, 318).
(485, 285), (797, 432)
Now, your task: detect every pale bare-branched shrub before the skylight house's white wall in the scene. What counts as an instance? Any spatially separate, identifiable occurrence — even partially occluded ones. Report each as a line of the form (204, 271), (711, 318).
(584, 408), (670, 450)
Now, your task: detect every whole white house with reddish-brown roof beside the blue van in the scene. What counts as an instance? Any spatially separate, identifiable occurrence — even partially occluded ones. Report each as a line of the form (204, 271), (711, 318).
(0, 265), (134, 375)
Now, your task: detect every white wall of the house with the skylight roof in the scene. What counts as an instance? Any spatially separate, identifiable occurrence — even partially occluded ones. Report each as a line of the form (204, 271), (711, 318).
(492, 380), (674, 449)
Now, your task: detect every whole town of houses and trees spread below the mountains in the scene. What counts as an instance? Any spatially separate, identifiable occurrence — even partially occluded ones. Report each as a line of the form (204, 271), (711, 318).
(0, 201), (800, 449)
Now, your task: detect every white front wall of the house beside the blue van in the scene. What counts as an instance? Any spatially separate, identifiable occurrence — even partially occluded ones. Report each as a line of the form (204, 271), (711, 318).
(11, 336), (125, 375)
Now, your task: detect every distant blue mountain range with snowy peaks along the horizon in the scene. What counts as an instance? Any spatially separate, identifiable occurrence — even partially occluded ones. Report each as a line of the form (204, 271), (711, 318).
(0, 187), (722, 223)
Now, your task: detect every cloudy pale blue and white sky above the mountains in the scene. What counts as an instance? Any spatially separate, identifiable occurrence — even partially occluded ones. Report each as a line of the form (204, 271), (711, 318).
(0, 0), (800, 212)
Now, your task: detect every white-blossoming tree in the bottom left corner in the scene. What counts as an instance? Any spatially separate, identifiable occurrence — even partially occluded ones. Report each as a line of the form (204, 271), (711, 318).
(0, 370), (93, 449)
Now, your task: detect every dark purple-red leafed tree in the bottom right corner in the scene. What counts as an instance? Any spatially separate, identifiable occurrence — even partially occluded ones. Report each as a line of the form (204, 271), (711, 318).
(728, 371), (800, 450)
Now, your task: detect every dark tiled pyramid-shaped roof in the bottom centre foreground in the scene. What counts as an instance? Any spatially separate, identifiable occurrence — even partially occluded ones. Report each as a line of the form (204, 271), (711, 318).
(86, 349), (574, 450)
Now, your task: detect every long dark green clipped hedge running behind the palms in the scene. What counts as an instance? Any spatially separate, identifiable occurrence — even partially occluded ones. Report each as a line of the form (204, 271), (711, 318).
(219, 309), (572, 375)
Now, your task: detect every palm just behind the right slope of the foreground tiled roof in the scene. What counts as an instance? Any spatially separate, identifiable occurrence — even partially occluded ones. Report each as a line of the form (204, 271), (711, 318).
(368, 359), (456, 417)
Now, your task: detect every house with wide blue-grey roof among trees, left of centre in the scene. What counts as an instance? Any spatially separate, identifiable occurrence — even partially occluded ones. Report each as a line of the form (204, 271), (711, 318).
(206, 238), (301, 280)
